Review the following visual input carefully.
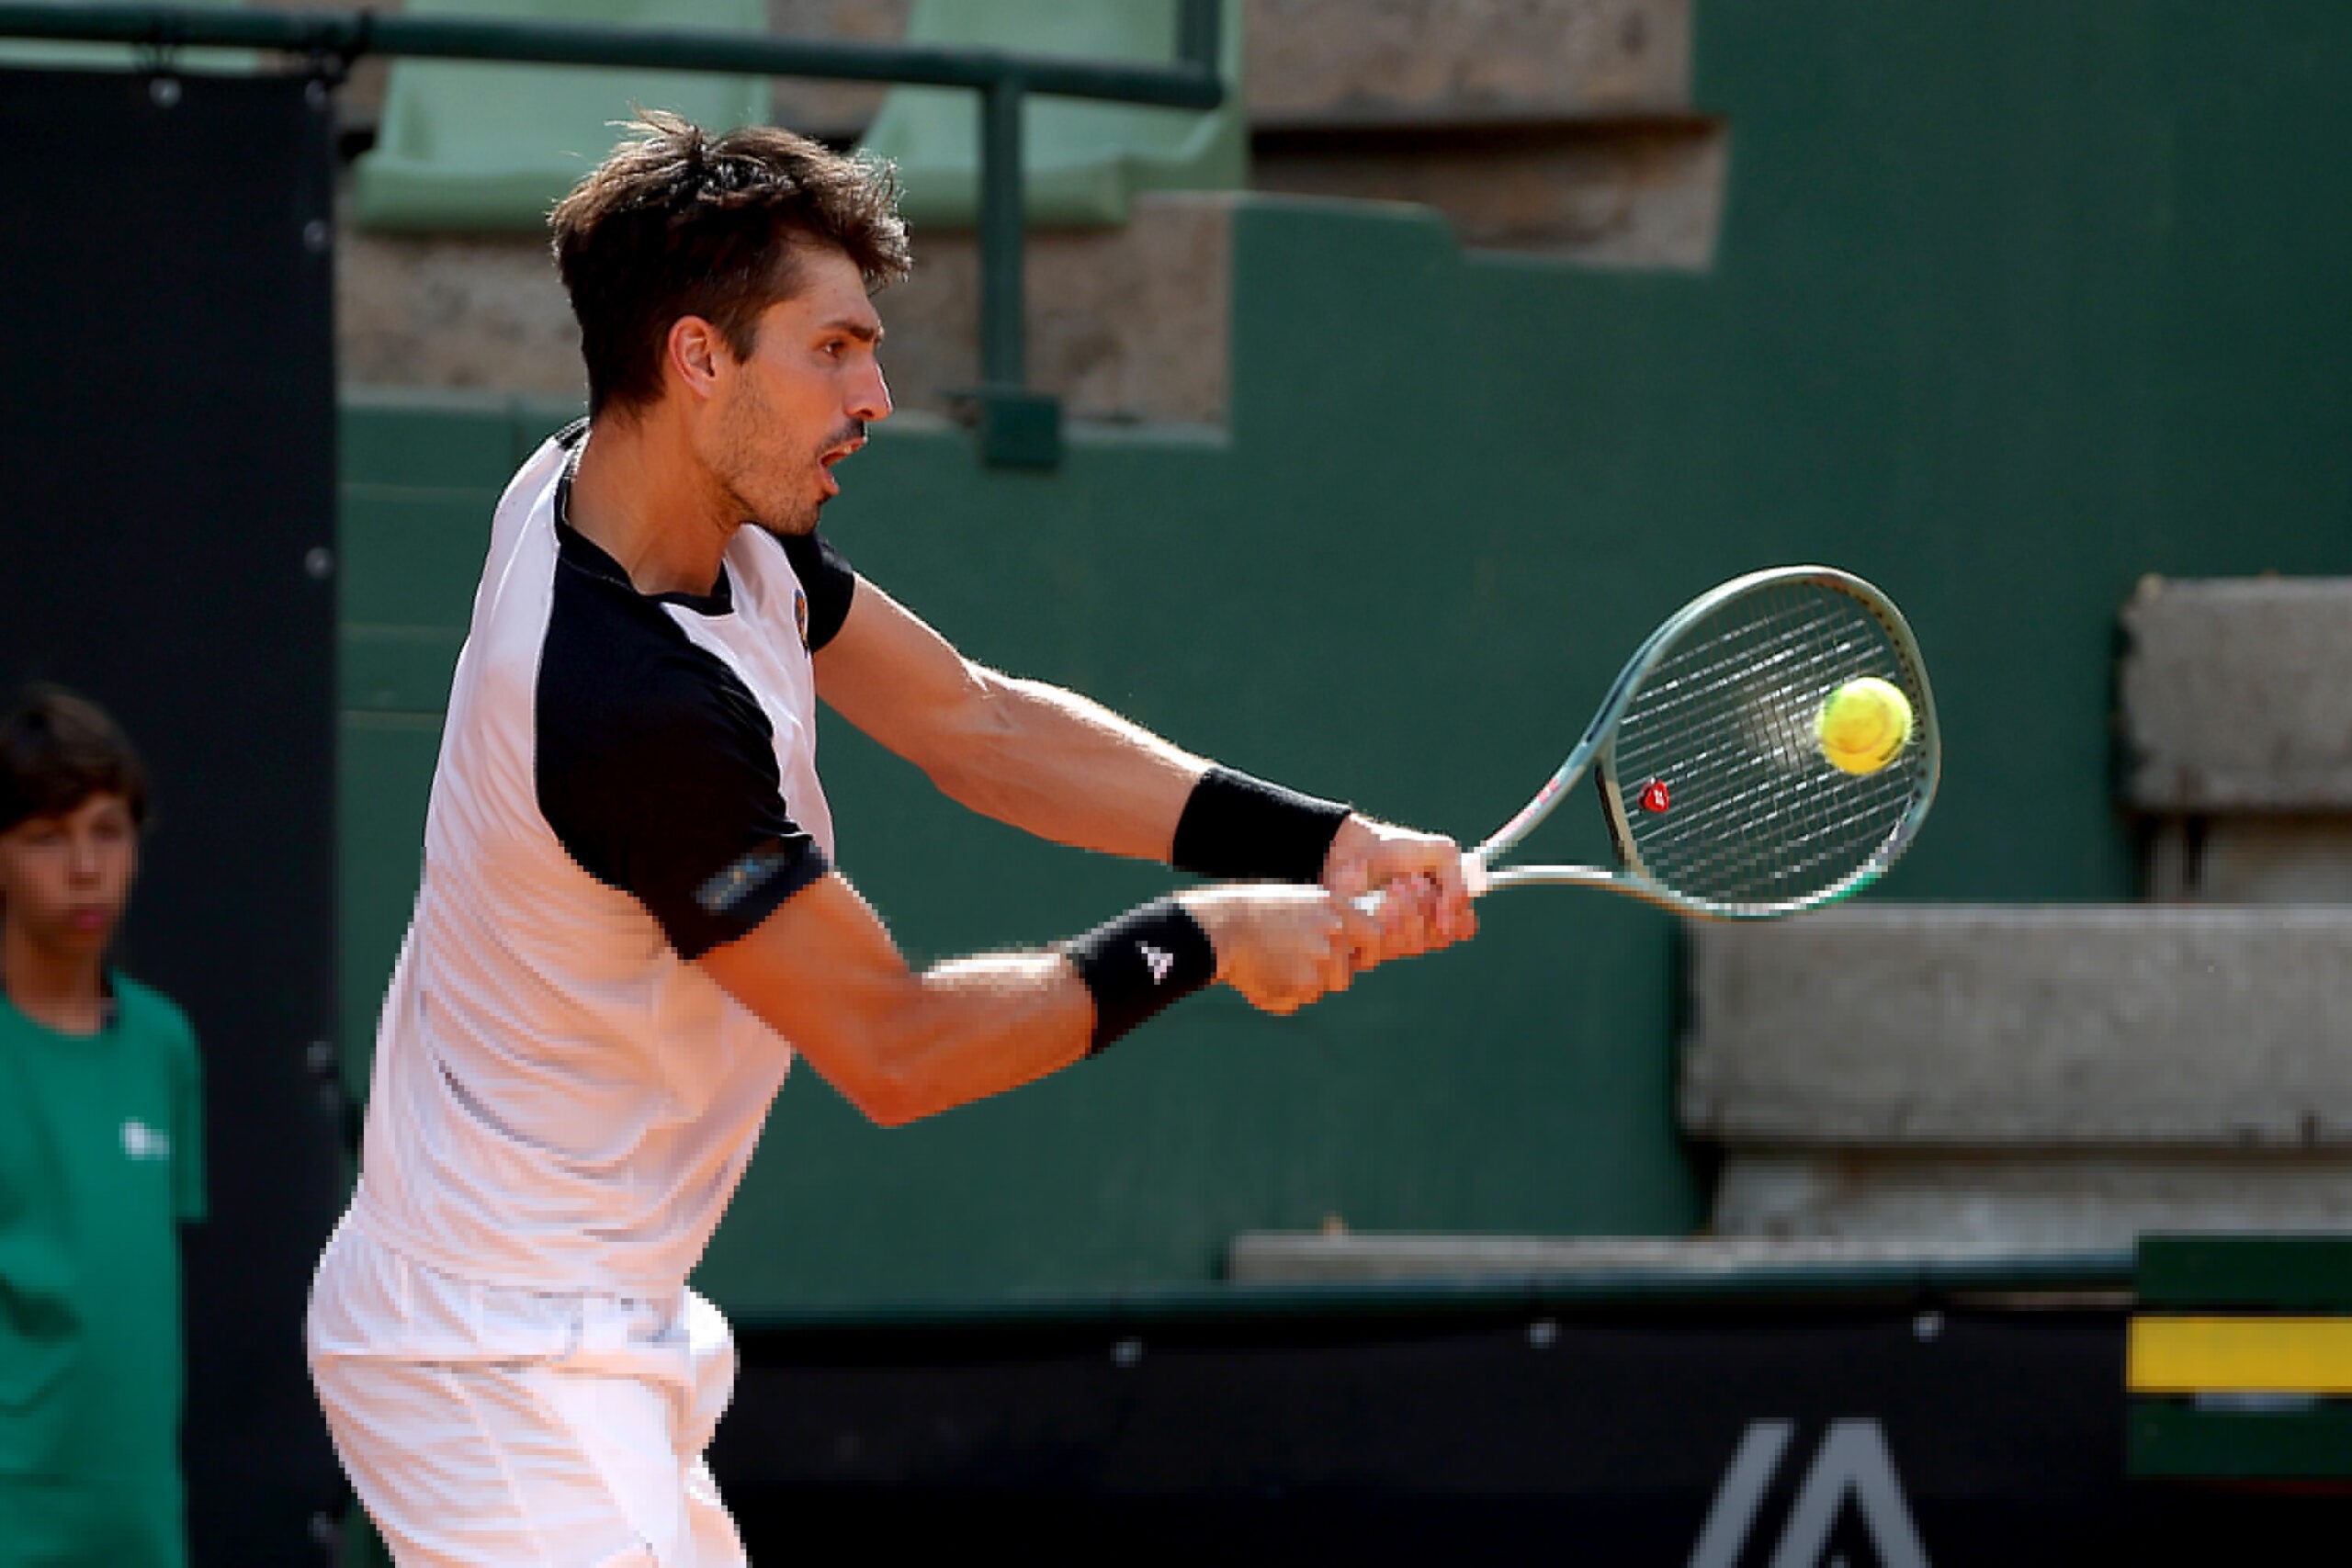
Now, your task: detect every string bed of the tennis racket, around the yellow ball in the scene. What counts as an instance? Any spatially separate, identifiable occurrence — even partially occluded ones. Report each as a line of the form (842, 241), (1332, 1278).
(1616, 583), (1927, 909)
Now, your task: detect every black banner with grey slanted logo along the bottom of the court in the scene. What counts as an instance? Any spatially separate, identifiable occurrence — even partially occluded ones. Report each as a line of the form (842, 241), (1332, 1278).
(713, 1304), (2340, 1568)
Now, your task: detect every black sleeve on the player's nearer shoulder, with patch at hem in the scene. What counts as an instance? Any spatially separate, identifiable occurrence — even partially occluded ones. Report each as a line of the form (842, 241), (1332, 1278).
(537, 581), (828, 959)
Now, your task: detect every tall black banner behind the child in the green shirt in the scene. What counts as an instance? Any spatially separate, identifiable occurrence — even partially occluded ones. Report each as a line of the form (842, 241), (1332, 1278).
(0, 71), (344, 1568)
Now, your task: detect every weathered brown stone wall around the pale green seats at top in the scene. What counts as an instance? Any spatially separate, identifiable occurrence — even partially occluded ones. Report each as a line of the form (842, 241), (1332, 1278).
(326, 0), (1724, 411)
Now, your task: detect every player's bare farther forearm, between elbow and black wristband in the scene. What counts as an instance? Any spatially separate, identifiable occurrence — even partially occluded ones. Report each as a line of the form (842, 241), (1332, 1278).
(932, 674), (1209, 861)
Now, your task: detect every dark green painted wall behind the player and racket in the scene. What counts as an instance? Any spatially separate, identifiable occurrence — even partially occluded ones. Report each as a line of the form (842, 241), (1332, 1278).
(344, 0), (2352, 1309)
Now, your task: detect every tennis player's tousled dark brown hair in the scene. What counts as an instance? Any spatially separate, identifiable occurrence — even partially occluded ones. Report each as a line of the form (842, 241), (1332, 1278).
(548, 110), (908, 413)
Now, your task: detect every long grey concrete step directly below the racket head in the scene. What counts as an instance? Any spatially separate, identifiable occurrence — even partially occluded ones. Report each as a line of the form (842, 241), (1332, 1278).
(1681, 903), (2352, 1149)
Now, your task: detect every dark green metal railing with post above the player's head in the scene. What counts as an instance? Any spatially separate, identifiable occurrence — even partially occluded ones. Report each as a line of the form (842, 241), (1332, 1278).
(0, 0), (1226, 466)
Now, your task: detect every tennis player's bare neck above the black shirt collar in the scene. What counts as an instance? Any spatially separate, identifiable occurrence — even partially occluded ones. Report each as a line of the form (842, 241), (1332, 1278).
(571, 412), (734, 592)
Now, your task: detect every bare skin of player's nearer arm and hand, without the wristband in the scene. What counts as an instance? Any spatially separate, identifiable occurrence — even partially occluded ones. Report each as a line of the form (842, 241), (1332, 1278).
(696, 872), (1381, 1126)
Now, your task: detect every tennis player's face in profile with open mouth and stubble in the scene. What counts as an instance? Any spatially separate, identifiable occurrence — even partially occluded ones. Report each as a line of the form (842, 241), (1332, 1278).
(715, 249), (891, 534)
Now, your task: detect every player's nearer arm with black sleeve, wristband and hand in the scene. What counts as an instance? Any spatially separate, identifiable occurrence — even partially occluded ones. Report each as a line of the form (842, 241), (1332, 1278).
(534, 564), (1428, 1123)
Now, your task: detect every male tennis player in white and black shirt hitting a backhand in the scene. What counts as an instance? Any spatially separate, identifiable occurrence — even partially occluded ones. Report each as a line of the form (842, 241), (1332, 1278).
(308, 115), (1470, 1568)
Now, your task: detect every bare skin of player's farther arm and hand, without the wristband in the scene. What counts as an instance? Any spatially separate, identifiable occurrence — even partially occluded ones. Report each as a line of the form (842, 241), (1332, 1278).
(816, 579), (1473, 945)
